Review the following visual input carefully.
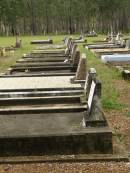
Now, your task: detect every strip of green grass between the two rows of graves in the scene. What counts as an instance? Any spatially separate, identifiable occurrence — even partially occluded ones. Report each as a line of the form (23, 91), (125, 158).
(78, 37), (127, 110)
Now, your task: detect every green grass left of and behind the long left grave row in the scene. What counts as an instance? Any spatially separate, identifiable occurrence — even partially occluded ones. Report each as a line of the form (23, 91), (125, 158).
(0, 36), (64, 72)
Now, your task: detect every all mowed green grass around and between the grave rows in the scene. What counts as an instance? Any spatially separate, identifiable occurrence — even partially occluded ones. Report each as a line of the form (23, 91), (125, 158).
(0, 35), (127, 110)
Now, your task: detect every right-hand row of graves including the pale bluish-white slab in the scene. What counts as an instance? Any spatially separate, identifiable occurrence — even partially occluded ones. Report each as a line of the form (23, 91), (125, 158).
(85, 33), (130, 80)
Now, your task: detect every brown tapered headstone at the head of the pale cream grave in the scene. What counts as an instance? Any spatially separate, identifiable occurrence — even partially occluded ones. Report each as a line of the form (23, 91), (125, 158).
(75, 54), (87, 80)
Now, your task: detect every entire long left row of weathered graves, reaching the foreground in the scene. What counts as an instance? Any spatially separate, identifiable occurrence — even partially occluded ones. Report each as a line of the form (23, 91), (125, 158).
(0, 39), (127, 163)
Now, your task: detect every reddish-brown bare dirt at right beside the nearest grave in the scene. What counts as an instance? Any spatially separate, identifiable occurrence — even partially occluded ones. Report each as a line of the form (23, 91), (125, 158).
(105, 80), (130, 153)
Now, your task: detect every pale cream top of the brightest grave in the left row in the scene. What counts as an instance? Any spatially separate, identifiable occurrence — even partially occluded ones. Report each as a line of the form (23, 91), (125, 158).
(0, 76), (81, 91)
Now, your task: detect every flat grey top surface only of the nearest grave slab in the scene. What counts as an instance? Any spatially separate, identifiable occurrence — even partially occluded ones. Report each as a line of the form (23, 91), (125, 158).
(0, 113), (110, 138)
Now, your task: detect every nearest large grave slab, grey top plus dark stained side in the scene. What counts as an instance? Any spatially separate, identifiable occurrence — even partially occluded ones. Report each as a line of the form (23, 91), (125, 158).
(0, 113), (112, 156)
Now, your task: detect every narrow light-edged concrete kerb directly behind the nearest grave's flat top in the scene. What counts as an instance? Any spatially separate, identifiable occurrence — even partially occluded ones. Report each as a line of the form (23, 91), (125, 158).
(0, 101), (87, 116)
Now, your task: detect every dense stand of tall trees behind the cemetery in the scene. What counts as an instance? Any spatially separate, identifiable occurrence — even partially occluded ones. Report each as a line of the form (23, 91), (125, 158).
(0, 0), (130, 35)
